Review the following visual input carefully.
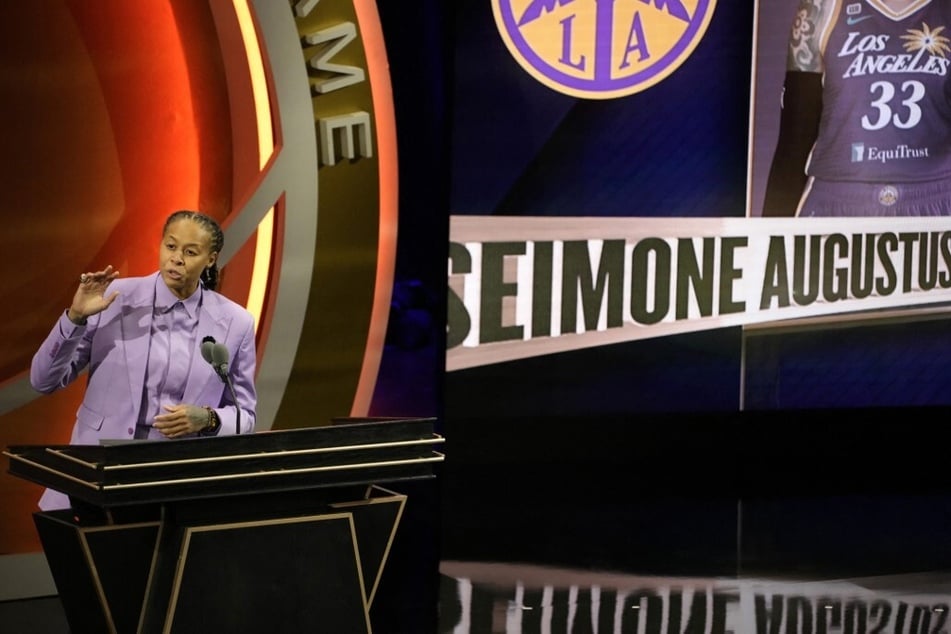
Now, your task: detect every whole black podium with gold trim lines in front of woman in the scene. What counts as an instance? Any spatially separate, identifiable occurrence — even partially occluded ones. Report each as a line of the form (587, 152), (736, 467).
(4, 418), (443, 634)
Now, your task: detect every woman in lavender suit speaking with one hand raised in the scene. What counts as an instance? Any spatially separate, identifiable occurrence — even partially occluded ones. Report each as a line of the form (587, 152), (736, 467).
(30, 211), (257, 510)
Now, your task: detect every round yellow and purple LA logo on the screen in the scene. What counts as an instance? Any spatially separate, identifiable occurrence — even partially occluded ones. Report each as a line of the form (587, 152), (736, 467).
(492, 0), (716, 99)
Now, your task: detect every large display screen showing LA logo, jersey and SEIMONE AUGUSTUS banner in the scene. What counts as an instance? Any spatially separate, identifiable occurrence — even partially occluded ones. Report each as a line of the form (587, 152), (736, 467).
(446, 0), (951, 416)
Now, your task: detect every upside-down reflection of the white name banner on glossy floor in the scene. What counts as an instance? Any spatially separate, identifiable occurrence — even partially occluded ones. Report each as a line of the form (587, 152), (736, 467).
(439, 561), (951, 634)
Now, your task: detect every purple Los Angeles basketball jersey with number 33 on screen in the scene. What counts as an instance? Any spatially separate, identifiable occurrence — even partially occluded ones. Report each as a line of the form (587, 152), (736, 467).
(807, 0), (951, 183)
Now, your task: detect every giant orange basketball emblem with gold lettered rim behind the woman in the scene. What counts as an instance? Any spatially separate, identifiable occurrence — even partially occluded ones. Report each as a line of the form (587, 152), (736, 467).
(0, 0), (397, 556)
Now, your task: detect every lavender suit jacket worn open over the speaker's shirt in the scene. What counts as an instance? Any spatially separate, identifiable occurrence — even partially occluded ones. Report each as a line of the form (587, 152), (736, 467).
(30, 273), (257, 509)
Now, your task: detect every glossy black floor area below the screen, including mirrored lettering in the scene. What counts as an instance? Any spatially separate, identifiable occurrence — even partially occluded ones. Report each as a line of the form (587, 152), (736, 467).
(439, 412), (951, 634)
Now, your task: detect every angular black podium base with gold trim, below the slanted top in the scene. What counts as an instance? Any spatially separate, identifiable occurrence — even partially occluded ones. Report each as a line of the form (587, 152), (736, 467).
(34, 486), (406, 634)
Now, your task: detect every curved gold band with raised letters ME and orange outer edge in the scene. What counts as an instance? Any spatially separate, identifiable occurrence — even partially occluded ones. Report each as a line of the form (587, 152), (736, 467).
(268, 0), (397, 425)
